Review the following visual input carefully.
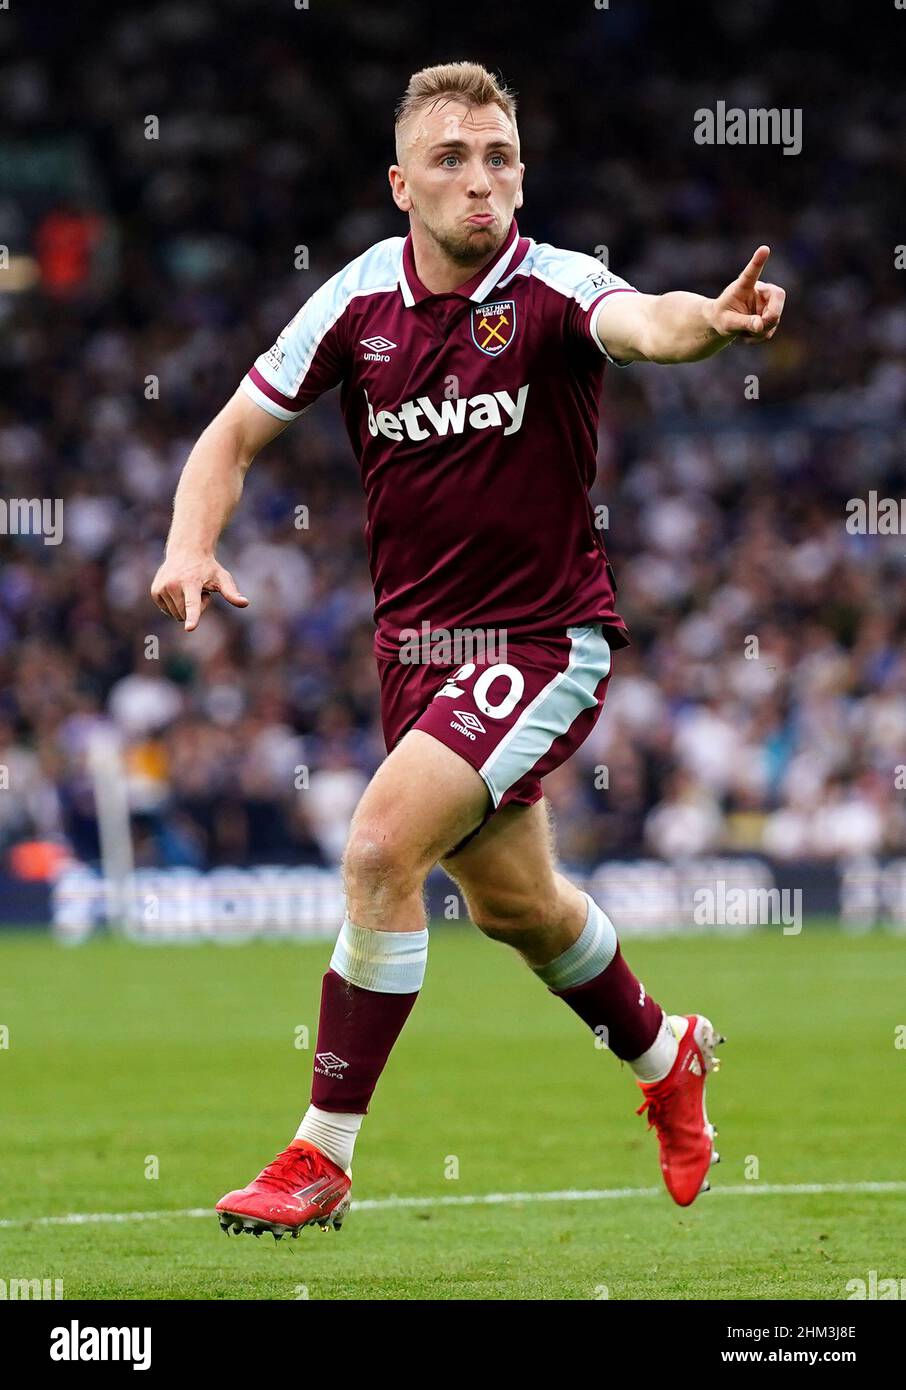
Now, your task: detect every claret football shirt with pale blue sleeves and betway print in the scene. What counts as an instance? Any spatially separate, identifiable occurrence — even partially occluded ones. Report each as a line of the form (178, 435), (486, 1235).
(242, 222), (635, 657)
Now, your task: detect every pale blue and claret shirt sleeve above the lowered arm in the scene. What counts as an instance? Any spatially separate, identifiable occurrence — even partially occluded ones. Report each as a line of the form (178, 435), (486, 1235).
(242, 271), (352, 420)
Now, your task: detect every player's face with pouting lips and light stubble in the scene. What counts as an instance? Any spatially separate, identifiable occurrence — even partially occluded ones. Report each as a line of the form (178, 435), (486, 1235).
(390, 100), (524, 267)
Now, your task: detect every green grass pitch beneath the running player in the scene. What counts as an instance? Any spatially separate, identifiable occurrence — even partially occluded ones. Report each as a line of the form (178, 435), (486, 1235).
(0, 922), (906, 1300)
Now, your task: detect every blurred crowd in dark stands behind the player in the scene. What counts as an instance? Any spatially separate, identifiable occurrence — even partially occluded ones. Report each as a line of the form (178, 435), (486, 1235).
(0, 0), (906, 866)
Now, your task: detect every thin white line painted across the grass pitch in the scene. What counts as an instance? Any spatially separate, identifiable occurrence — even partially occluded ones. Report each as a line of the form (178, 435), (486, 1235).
(0, 1182), (906, 1230)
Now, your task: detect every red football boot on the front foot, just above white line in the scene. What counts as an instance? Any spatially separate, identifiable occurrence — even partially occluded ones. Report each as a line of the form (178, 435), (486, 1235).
(217, 1140), (352, 1240)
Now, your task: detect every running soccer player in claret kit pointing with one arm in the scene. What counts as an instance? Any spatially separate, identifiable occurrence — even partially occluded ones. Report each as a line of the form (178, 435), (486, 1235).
(151, 63), (784, 1238)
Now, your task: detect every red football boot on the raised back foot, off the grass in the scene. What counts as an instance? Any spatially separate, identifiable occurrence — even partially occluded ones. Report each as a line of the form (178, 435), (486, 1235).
(635, 1013), (724, 1207)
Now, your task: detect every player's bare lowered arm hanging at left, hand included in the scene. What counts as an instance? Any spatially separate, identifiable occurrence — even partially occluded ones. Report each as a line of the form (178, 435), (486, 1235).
(151, 389), (289, 632)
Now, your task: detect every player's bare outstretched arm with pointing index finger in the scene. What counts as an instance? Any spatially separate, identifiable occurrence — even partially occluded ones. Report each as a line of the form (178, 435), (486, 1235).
(595, 246), (786, 363)
